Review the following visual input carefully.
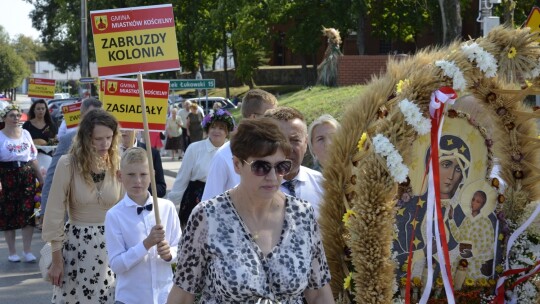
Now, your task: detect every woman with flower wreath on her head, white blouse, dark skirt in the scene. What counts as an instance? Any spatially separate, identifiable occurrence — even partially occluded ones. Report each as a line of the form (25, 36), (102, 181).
(168, 109), (234, 227)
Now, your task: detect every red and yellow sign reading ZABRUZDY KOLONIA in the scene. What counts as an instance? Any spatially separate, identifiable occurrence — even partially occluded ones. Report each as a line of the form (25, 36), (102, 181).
(90, 4), (180, 77)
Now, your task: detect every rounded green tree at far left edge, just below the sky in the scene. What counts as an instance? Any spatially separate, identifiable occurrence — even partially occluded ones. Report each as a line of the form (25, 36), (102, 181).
(0, 44), (30, 90)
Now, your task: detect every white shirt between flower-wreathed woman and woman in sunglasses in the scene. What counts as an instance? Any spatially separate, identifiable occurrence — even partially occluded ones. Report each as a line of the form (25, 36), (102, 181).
(202, 142), (240, 201)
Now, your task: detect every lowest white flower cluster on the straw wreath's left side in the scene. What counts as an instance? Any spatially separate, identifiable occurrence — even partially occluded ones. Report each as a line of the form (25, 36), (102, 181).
(373, 134), (409, 183)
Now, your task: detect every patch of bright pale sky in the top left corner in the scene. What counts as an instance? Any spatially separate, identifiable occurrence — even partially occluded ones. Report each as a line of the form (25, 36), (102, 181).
(0, 0), (39, 39)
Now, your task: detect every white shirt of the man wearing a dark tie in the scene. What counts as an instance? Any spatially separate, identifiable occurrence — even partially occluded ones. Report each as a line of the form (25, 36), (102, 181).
(280, 166), (323, 219)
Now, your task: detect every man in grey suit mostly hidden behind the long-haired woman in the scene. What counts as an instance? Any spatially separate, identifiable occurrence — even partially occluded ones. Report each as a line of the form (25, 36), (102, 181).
(40, 97), (103, 219)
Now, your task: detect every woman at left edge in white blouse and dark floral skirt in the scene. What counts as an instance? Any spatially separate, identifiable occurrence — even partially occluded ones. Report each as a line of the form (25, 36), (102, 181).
(0, 105), (43, 262)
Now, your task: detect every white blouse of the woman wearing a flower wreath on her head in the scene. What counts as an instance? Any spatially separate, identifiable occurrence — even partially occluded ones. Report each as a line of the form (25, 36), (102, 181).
(168, 138), (221, 205)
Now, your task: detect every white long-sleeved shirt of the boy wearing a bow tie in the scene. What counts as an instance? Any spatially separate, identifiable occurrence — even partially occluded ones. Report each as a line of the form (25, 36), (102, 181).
(105, 193), (182, 304)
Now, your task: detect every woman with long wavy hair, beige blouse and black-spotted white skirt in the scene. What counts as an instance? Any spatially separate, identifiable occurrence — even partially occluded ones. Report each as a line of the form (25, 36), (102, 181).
(43, 109), (123, 303)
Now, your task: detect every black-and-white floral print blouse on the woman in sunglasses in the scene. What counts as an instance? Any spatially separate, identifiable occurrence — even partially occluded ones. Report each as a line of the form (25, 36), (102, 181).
(174, 191), (330, 304)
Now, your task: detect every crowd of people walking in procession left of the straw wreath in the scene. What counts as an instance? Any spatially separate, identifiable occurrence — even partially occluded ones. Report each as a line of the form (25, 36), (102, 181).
(0, 89), (339, 304)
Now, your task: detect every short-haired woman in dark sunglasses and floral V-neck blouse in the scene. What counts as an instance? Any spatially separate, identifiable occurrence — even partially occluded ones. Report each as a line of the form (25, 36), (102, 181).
(167, 118), (334, 304)
